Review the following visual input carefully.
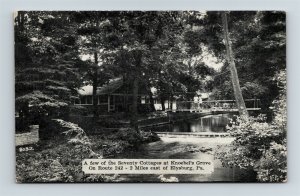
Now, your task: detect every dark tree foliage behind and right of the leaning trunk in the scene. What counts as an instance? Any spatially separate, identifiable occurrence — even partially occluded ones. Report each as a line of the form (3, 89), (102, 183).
(208, 12), (286, 112)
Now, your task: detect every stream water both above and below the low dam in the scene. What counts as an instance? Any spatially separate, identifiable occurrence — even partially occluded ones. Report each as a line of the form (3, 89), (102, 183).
(116, 114), (256, 182)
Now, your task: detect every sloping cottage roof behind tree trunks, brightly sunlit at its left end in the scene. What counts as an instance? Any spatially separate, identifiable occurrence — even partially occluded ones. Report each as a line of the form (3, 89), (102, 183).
(78, 77), (123, 95)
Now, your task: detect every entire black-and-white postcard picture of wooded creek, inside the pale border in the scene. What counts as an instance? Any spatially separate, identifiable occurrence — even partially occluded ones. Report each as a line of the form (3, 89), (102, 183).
(14, 11), (287, 183)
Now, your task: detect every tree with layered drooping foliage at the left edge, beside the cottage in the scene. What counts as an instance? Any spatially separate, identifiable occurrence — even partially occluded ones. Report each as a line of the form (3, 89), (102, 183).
(15, 11), (82, 127)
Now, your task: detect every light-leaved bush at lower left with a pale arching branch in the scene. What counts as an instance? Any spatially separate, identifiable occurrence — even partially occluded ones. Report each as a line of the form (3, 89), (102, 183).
(16, 119), (105, 182)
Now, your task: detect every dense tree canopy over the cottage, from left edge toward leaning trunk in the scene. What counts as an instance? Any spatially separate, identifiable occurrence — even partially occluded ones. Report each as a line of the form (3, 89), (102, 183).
(15, 11), (218, 130)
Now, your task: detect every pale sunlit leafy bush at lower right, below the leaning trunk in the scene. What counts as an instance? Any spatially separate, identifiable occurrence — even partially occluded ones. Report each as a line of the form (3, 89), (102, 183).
(218, 71), (287, 182)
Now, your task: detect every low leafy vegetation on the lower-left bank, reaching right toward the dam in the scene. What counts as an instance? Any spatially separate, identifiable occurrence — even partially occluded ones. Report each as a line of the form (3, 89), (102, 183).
(16, 120), (159, 183)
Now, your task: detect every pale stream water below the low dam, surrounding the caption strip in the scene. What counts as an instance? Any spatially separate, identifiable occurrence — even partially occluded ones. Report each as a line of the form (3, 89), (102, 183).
(113, 137), (256, 182)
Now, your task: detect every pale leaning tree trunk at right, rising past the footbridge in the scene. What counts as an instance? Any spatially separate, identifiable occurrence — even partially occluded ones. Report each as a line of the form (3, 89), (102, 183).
(222, 12), (249, 120)
